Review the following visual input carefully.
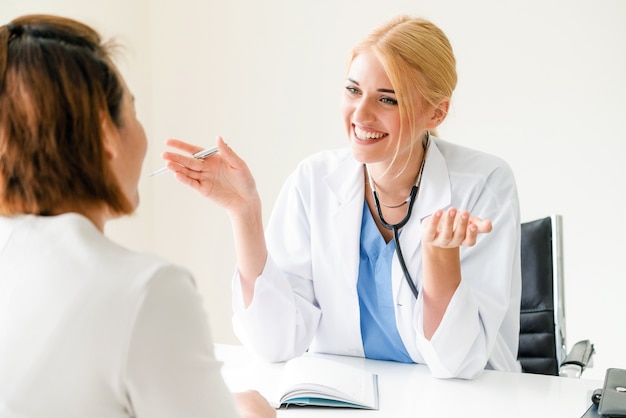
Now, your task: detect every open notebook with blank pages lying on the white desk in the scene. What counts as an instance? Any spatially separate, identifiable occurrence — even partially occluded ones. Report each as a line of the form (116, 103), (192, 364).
(277, 356), (378, 409)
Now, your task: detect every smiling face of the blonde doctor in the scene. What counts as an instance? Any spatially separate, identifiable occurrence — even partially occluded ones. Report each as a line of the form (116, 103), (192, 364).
(341, 50), (426, 170)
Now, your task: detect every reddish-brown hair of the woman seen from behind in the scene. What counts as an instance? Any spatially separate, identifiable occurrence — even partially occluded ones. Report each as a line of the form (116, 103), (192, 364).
(0, 15), (133, 215)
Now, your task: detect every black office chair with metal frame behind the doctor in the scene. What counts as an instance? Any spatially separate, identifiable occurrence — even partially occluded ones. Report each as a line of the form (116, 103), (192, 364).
(518, 215), (594, 377)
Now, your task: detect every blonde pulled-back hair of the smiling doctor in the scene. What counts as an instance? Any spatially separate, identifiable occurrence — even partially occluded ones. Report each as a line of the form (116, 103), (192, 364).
(350, 16), (457, 140)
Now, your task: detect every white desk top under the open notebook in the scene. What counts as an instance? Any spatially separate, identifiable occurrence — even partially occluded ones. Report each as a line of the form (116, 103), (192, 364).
(216, 344), (602, 418)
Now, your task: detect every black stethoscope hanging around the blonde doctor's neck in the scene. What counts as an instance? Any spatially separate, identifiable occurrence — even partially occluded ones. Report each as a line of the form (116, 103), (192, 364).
(365, 131), (430, 299)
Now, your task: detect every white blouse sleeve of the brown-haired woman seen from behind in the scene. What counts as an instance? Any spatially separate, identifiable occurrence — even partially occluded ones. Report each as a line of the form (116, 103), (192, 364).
(126, 266), (239, 418)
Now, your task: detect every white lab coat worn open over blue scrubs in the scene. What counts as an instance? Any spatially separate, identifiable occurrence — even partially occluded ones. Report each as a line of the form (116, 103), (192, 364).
(233, 137), (521, 378)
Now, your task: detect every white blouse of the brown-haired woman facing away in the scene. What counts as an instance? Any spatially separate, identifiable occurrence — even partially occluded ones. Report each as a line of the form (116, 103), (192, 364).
(0, 214), (238, 418)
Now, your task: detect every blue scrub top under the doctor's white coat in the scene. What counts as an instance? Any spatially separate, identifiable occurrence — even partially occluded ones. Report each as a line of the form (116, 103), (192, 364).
(357, 202), (413, 363)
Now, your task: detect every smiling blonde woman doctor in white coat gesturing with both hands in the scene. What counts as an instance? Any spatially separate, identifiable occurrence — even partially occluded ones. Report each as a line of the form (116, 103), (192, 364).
(163, 16), (521, 378)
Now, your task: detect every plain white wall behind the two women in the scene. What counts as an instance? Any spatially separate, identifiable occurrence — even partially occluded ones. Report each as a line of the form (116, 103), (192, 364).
(0, 0), (626, 378)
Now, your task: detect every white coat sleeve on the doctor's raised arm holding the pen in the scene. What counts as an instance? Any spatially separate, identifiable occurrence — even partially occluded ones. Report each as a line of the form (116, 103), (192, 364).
(233, 167), (321, 362)
